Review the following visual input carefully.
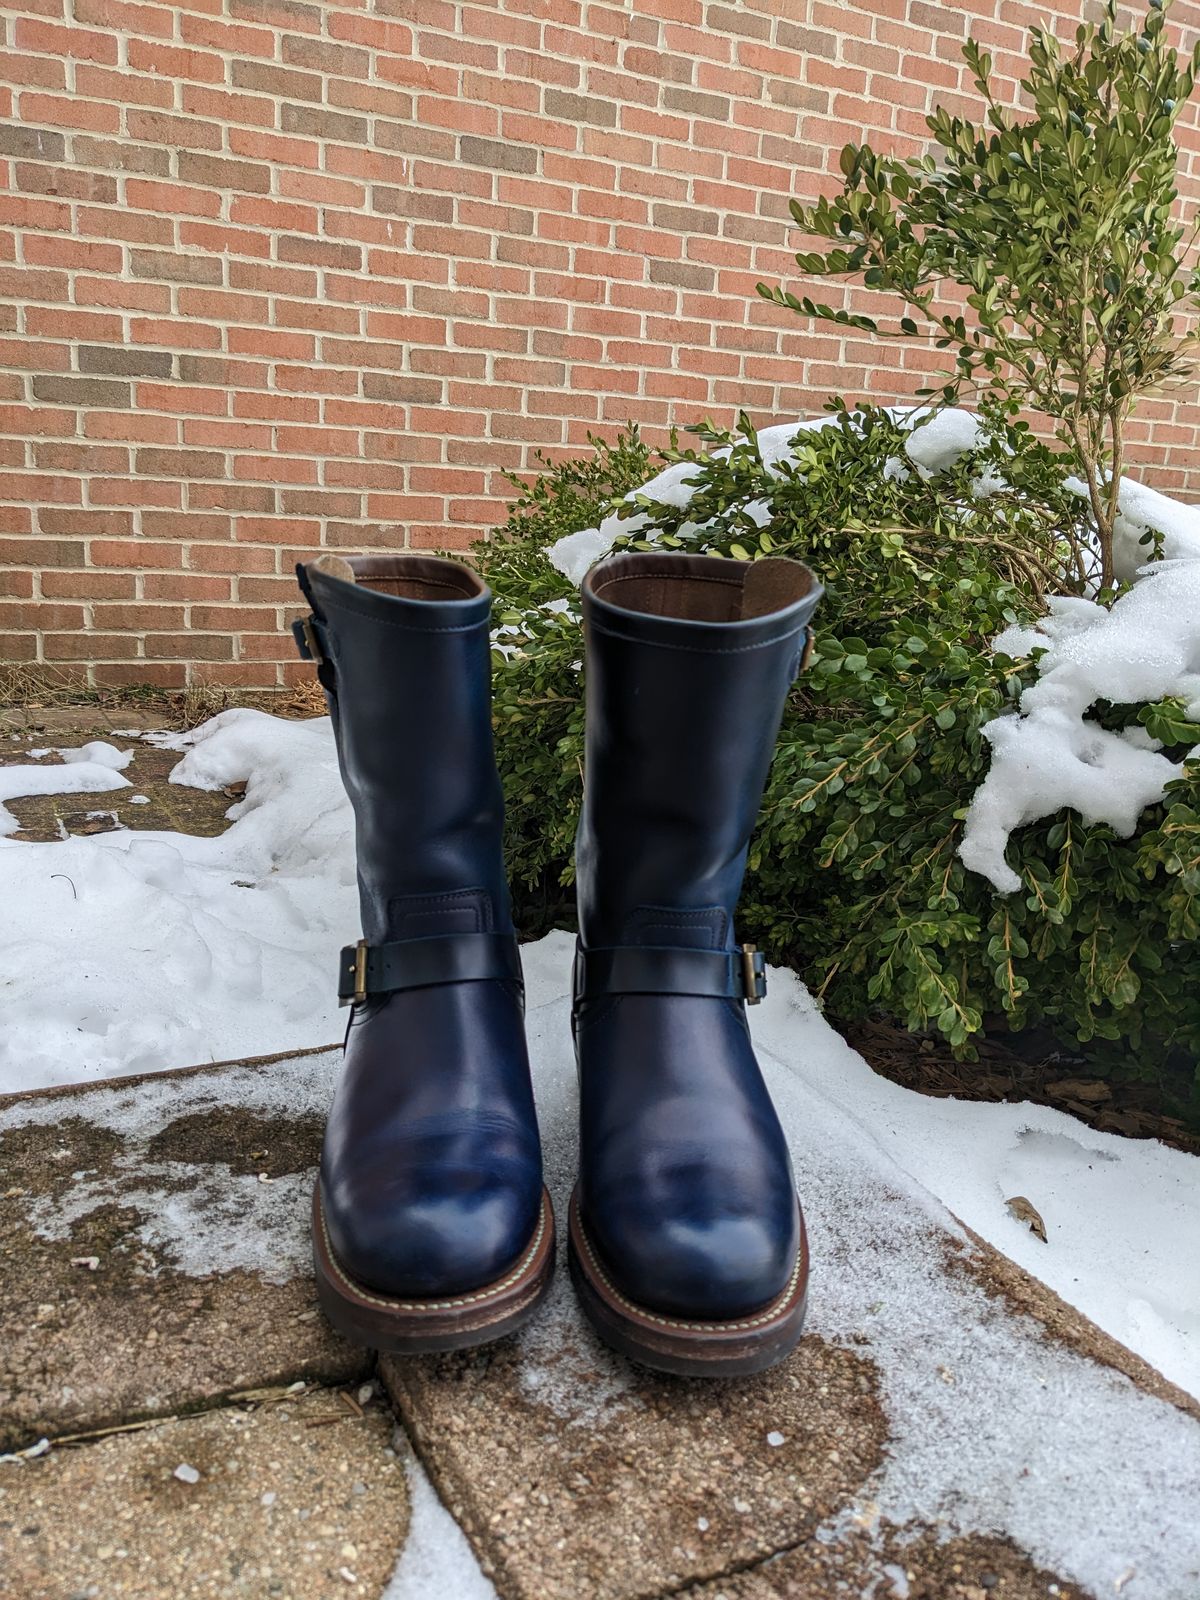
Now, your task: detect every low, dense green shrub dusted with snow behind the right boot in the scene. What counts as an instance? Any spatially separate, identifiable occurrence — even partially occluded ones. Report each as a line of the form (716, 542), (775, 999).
(477, 410), (1200, 1132)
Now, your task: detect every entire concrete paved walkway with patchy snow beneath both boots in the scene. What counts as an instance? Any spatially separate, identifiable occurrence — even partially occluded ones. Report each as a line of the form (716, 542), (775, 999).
(0, 1036), (1200, 1600)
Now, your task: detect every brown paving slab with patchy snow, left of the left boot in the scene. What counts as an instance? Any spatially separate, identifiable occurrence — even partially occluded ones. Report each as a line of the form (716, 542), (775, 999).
(0, 1051), (371, 1448)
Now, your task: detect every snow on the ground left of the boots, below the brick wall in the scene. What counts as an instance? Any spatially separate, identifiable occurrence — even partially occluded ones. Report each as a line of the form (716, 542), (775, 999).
(0, 710), (358, 1093)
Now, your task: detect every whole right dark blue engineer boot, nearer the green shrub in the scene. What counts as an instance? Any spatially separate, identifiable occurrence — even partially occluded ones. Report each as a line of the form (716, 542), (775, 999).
(570, 554), (821, 1376)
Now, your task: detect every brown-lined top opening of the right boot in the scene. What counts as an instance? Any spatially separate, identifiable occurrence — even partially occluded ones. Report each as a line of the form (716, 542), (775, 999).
(586, 552), (814, 622)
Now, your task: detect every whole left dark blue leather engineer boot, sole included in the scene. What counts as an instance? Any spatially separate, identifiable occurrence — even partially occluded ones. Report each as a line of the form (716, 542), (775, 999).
(294, 555), (554, 1352)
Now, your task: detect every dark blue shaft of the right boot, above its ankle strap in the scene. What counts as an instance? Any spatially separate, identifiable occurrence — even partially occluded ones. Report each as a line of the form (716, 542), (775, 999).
(576, 554), (821, 949)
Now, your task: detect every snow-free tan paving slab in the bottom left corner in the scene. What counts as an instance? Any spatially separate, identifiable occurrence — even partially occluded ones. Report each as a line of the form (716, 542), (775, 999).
(0, 1390), (408, 1600)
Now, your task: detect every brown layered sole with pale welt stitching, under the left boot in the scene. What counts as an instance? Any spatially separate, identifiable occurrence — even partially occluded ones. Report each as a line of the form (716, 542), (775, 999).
(312, 1182), (554, 1355)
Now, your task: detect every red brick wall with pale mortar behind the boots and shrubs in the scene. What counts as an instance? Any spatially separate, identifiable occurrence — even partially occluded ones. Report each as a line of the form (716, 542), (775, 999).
(0, 0), (1200, 686)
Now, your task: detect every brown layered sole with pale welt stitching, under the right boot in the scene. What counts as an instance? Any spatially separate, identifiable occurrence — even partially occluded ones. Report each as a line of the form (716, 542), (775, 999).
(566, 1189), (808, 1378)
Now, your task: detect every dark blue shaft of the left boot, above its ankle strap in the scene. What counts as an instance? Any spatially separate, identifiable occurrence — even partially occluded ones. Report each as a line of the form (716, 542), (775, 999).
(298, 555), (512, 944)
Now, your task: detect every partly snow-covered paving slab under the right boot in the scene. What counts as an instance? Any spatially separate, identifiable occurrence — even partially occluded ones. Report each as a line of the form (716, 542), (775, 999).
(381, 1000), (1200, 1600)
